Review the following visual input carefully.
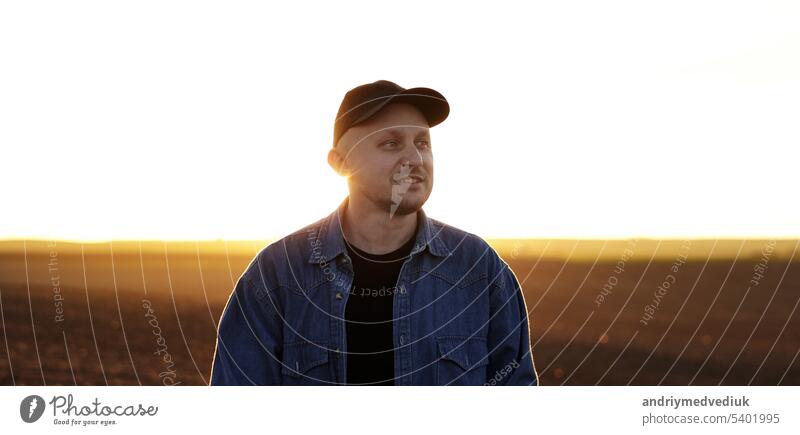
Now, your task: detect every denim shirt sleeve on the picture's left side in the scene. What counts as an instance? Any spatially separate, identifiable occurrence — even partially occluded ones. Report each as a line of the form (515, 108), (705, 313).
(210, 270), (282, 385)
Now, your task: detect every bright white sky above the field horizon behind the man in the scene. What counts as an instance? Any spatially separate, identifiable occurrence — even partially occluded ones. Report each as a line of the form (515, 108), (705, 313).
(0, 0), (800, 240)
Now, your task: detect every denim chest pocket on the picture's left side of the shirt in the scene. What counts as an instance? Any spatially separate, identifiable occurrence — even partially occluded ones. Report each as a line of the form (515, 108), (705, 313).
(281, 341), (333, 385)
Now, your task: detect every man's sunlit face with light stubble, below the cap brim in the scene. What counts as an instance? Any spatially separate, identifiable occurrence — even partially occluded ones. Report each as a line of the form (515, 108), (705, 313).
(336, 103), (433, 218)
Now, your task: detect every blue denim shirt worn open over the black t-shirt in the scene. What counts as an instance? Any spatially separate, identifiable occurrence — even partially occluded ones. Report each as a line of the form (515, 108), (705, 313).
(210, 198), (538, 385)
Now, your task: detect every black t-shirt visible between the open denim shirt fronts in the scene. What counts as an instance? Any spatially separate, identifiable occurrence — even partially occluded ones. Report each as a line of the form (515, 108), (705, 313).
(344, 227), (416, 385)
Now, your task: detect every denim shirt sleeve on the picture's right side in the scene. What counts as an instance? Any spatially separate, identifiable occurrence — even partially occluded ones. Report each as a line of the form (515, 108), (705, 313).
(487, 260), (539, 385)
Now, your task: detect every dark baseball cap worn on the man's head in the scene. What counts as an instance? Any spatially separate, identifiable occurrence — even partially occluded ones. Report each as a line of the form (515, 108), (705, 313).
(333, 80), (450, 146)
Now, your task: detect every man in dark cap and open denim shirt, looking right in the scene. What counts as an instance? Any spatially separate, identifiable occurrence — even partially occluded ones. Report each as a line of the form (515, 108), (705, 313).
(211, 80), (538, 385)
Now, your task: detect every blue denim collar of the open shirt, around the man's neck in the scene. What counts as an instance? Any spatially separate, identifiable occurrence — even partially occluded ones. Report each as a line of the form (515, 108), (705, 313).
(308, 196), (450, 263)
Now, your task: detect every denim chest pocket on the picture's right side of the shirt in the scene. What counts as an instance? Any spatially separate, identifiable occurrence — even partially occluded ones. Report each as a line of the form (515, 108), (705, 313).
(436, 336), (489, 385)
